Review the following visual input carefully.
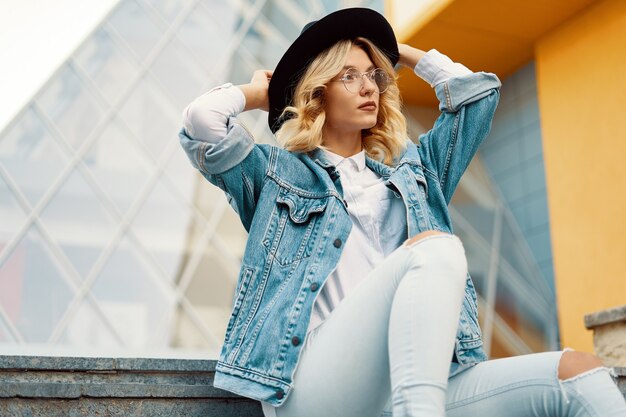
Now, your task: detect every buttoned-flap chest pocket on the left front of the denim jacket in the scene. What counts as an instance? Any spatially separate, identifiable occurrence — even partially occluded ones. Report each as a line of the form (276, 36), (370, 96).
(263, 188), (330, 265)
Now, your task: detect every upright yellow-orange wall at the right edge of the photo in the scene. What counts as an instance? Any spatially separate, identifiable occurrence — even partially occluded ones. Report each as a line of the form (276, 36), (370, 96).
(536, 0), (626, 351)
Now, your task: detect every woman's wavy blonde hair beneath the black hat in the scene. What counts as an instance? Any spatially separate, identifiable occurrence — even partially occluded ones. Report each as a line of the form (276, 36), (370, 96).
(276, 38), (409, 166)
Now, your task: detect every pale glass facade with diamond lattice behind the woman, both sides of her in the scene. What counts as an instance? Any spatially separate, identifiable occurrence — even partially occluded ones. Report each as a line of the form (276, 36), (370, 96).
(0, 0), (556, 358)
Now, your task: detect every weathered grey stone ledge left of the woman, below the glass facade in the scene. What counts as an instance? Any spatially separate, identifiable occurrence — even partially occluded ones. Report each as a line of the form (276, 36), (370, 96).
(0, 356), (263, 417)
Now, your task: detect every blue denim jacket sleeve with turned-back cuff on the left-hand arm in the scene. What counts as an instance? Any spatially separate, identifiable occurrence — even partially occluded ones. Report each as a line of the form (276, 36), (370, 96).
(179, 117), (271, 231)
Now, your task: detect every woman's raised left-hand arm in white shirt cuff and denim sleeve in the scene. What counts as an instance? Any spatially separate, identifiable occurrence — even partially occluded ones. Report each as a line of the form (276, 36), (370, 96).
(179, 70), (272, 230)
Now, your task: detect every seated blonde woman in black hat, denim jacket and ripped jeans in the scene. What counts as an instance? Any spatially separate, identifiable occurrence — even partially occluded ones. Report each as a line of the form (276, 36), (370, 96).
(180, 8), (626, 417)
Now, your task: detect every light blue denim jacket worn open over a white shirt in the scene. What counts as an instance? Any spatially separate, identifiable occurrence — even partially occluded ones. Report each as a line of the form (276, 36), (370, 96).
(179, 72), (500, 406)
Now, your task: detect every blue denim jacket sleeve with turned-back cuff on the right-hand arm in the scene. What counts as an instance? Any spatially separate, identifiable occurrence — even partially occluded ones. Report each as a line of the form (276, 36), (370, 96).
(419, 72), (501, 204)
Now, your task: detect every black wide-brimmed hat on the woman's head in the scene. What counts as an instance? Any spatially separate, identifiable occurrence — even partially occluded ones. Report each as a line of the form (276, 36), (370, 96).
(267, 7), (400, 133)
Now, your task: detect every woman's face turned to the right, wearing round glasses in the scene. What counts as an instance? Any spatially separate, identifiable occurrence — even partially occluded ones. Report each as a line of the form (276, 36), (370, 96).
(324, 45), (380, 133)
